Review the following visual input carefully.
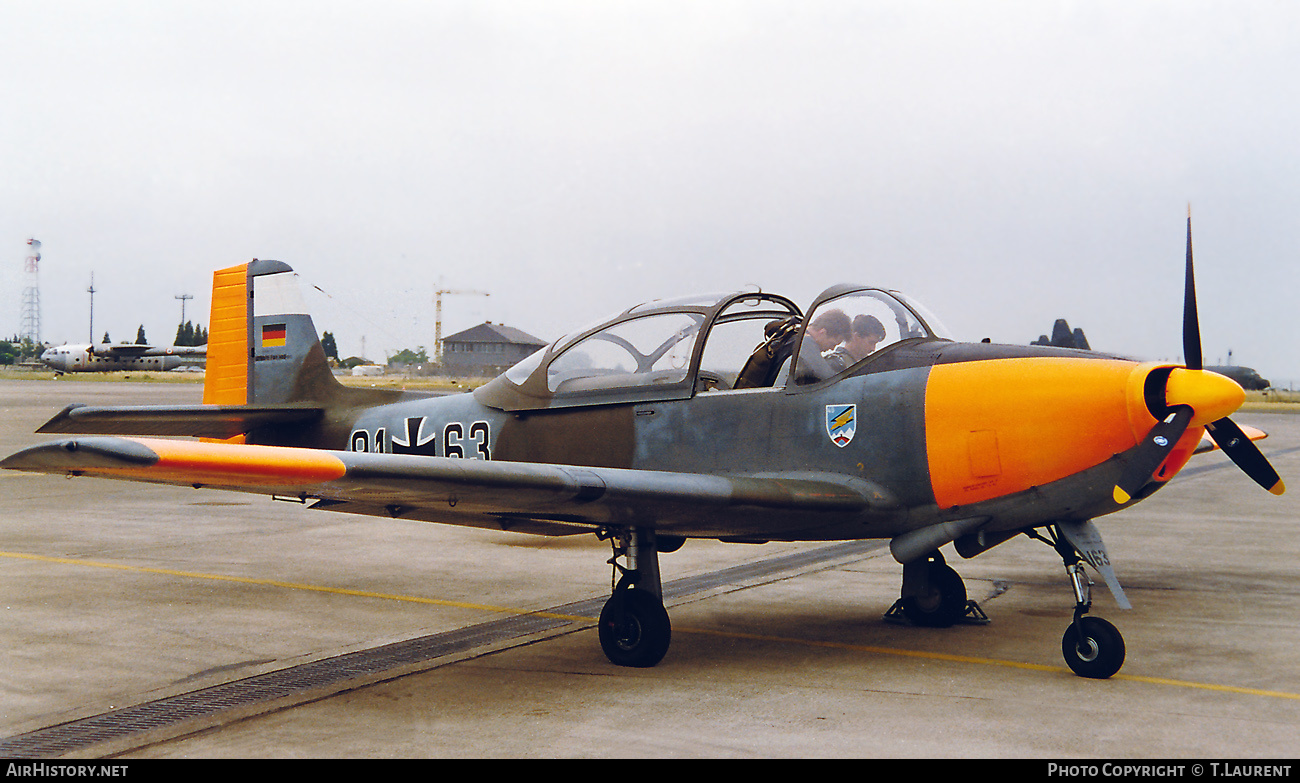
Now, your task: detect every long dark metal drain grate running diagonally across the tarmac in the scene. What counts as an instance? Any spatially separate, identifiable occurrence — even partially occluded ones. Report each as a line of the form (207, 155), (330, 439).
(0, 541), (883, 758)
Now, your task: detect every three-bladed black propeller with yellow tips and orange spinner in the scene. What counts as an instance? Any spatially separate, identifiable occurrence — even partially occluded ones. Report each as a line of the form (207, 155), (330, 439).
(1114, 213), (1286, 503)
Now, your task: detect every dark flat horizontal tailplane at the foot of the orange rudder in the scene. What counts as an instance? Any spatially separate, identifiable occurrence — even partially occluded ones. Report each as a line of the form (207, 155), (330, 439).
(36, 405), (324, 438)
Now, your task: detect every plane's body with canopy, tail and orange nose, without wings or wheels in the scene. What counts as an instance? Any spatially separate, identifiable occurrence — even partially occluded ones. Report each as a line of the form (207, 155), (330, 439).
(204, 263), (1244, 549)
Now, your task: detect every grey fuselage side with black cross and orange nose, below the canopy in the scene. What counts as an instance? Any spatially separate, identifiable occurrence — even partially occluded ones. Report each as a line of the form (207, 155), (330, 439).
(342, 339), (1200, 538)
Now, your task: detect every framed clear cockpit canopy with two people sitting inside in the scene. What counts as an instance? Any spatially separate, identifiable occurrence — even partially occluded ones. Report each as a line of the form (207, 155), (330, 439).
(476, 285), (948, 411)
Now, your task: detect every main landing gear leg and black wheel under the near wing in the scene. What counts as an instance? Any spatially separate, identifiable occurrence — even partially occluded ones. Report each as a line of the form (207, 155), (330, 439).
(599, 528), (672, 667)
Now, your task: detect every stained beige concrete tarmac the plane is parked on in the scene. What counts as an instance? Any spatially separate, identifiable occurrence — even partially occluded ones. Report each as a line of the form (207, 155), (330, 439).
(0, 380), (1300, 761)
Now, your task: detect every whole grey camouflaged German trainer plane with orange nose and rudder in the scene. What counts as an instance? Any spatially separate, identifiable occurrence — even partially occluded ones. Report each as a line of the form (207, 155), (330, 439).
(0, 251), (1282, 676)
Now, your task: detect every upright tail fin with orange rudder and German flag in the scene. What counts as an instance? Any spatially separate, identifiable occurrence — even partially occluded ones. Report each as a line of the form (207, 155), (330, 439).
(203, 259), (347, 405)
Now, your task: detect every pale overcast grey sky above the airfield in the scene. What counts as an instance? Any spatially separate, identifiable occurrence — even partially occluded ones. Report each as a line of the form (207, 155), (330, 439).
(0, 0), (1300, 385)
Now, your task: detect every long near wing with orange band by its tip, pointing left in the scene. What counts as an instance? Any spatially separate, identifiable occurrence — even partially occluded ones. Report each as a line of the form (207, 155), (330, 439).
(0, 437), (898, 538)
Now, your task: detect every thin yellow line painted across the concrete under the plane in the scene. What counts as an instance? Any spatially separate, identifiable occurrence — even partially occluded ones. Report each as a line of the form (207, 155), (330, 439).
(10, 551), (1300, 701)
